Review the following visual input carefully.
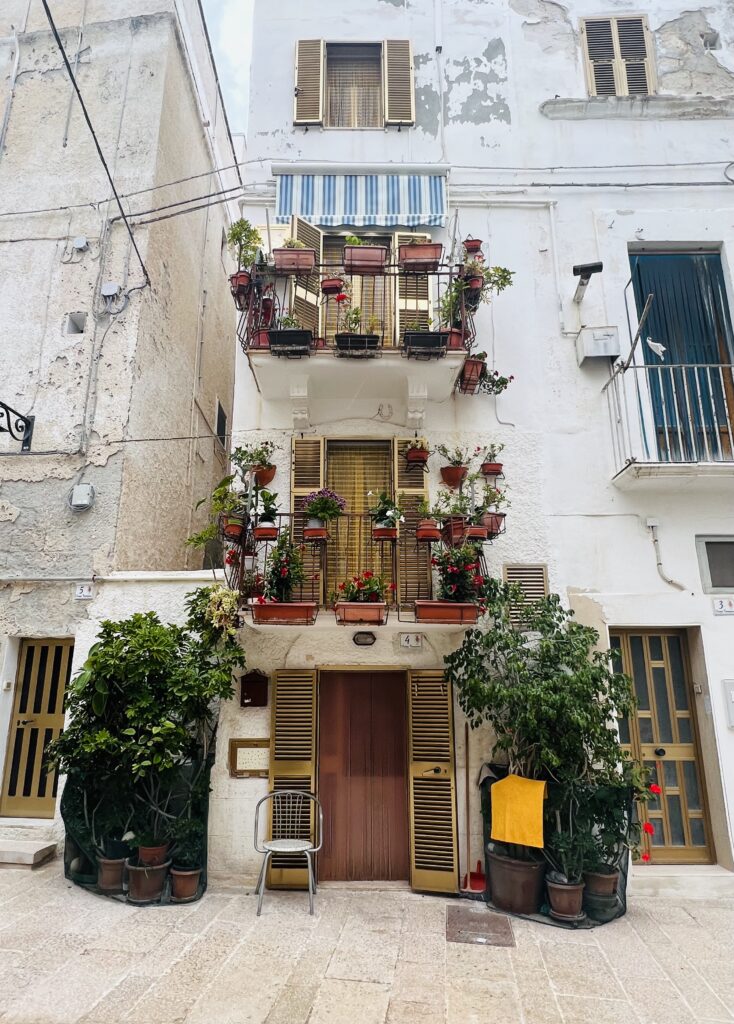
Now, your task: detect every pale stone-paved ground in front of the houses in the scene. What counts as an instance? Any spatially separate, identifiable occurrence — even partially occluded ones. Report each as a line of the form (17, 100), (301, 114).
(0, 861), (734, 1024)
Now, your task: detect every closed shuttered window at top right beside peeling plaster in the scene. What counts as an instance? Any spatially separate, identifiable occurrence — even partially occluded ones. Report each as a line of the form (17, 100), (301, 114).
(581, 16), (655, 96)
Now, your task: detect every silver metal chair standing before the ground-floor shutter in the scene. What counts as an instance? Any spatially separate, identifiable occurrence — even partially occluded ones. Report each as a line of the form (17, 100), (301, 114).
(255, 790), (323, 918)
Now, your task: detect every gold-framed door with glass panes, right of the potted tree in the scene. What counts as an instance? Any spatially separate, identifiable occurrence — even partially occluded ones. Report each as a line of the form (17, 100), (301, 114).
(611, 630), (713, 864)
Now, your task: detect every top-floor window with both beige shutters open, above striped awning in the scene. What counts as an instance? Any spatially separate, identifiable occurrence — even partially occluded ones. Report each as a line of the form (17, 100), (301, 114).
(293, 39), (415, 128)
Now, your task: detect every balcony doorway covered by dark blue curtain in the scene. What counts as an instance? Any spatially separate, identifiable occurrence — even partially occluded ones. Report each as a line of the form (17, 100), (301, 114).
(631, 252), (734, 462)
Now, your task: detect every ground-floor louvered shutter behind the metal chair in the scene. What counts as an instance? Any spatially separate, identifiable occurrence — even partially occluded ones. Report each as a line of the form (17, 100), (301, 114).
(267, 670), (316, 889)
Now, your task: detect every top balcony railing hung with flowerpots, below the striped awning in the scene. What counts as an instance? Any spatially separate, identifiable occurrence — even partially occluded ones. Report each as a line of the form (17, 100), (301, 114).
(238, 263), (481, 359)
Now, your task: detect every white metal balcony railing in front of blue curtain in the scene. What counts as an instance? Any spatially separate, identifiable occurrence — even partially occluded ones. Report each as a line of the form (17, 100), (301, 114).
(604, 364), (734, 472)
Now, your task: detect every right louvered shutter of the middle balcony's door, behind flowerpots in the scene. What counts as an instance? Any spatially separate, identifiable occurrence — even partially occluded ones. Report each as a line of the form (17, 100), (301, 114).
(393, 437), (431, 604)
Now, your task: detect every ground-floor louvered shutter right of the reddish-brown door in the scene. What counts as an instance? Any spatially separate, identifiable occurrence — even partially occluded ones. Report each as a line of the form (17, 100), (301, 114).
(408, 672), (459, 893)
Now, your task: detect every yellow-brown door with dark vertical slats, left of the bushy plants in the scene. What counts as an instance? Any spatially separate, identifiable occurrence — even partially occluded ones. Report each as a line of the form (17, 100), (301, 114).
(0, 640), (74, 818)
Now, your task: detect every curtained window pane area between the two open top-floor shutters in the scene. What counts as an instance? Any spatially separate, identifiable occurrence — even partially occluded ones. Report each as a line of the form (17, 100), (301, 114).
(326, 44), (384, 128)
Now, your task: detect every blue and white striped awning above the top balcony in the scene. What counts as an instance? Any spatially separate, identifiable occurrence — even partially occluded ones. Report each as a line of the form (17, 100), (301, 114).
(275, 174), (446, 227)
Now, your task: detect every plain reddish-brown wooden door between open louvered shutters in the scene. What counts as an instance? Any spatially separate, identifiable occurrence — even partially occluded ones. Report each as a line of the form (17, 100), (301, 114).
(318, 672), (411, 882)
